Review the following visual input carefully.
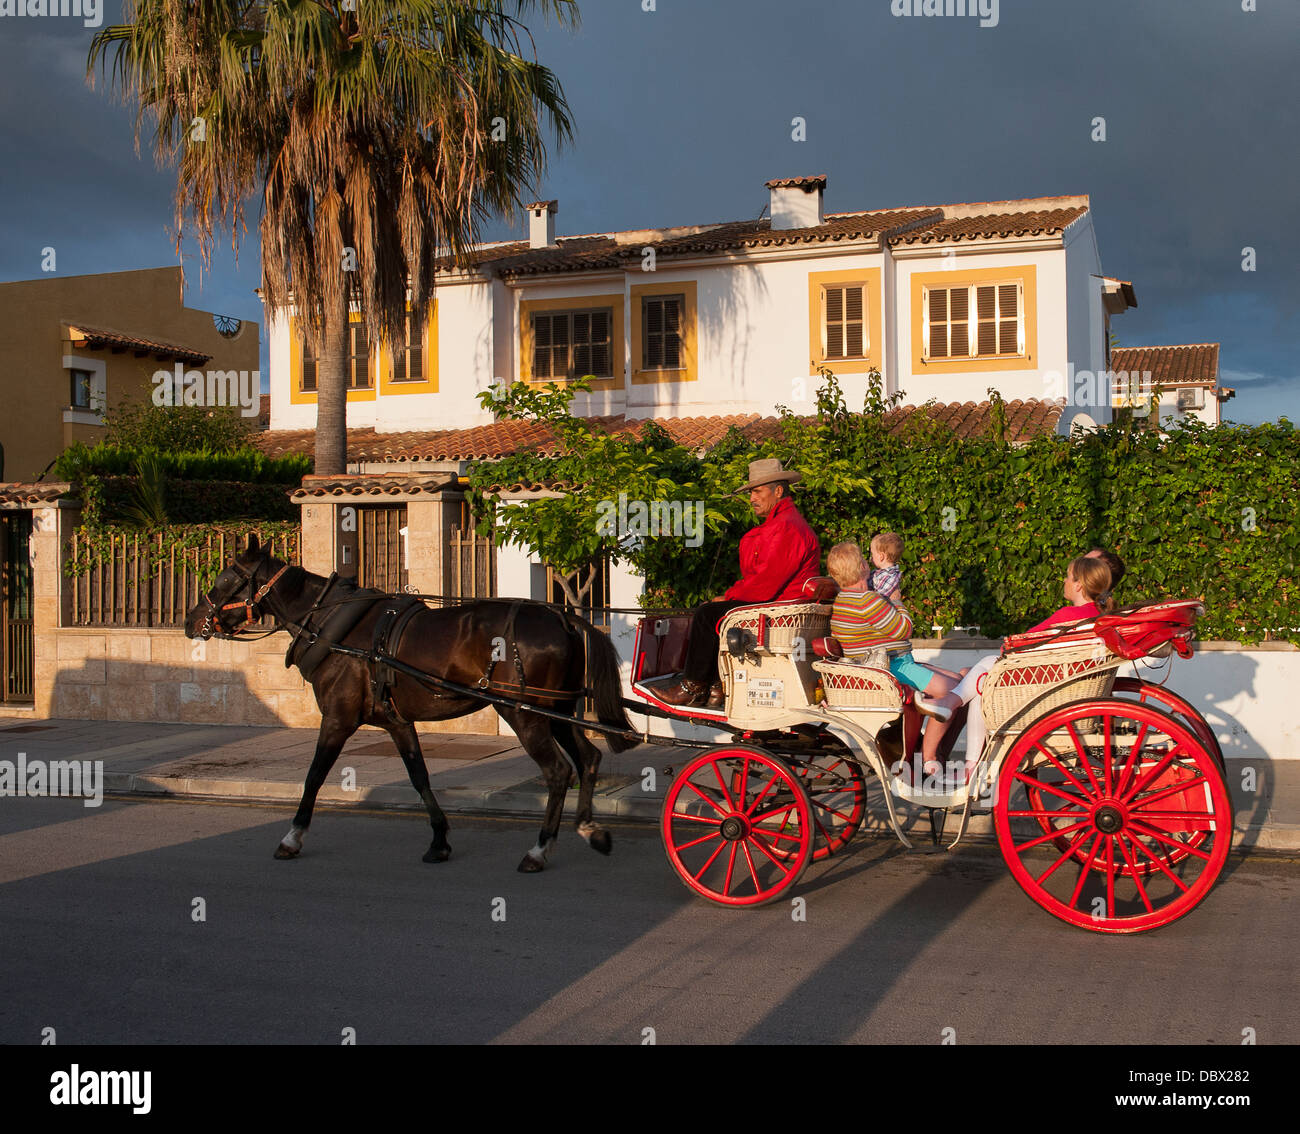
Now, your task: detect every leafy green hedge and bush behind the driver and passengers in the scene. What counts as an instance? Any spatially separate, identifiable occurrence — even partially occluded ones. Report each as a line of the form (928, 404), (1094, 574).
(471, 375), (1300, 641)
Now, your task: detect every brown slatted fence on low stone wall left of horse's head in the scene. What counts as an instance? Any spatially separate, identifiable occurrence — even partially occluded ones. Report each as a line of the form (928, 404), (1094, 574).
(69, 528), (302, 627)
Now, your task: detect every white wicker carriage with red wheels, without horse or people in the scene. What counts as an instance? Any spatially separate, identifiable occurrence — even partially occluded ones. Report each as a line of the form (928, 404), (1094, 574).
(633, 579), (1232, 932)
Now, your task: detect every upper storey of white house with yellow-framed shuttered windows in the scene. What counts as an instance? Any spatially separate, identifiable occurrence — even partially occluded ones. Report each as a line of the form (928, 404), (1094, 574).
(268, 177), (1136, 433)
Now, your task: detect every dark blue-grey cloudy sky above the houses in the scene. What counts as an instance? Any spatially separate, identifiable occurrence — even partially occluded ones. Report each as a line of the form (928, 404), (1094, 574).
(0, 0), (1300, 423)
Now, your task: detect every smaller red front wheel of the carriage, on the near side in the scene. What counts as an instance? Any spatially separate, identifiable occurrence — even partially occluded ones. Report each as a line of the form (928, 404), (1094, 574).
(662, 745), (815, 905)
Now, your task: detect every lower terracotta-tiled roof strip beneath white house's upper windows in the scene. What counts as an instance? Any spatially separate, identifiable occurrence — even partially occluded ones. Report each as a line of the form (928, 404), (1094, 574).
(254, 401), (1062, 468)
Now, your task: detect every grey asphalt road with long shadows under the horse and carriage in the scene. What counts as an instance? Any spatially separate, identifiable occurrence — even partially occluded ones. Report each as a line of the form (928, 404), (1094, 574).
(0, 798), (1300, 1047)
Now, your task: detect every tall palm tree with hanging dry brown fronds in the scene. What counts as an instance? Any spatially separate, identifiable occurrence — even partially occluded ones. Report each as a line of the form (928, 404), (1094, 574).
(87, 0), (577, 475)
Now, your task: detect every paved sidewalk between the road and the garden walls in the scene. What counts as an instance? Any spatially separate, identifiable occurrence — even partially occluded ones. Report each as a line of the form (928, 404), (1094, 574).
(0, 718), (1300, 853)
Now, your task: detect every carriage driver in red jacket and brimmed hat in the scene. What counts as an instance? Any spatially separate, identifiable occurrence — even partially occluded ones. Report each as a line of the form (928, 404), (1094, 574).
(659, 459), (822, 709)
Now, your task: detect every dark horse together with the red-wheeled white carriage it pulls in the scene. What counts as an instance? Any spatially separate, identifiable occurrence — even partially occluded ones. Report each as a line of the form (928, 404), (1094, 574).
(186, 538), (1232, 932)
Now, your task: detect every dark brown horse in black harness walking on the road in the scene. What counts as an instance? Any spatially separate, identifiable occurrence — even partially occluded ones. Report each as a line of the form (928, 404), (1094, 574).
(185, 536), (638, 874)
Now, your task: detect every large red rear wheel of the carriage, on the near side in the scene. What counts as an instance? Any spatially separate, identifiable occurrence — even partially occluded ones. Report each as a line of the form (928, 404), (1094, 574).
(993, 698), (1232, 934)
